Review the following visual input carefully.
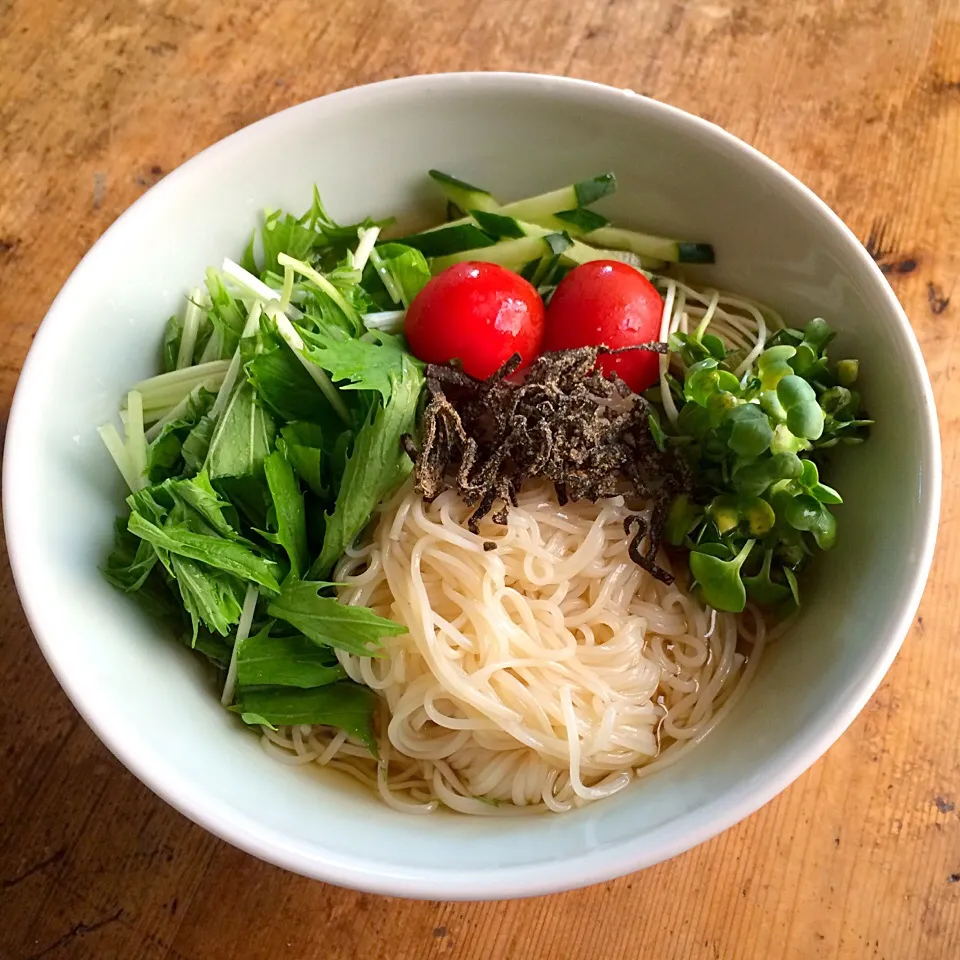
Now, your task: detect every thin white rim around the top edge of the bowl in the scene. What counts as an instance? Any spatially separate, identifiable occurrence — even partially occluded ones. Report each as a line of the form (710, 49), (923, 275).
(2, 72), (941, 900)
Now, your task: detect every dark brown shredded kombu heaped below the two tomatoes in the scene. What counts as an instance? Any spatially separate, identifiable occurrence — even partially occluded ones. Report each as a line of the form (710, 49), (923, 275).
(404, 343), (687, 583)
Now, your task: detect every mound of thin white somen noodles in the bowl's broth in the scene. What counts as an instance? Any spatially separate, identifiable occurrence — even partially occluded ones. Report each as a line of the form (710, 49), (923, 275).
(264, 482), (764, 814)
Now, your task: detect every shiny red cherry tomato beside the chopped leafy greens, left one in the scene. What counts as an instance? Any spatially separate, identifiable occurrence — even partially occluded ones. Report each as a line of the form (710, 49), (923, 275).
(404, 263), (544, 379)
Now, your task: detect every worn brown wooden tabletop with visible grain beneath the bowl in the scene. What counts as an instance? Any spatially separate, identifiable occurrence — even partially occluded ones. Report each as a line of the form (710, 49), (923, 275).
(0, 0), (960, 960)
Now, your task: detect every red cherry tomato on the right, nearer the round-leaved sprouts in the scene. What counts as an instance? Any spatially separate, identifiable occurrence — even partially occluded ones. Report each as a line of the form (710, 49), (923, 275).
(543, 260), (663, 393)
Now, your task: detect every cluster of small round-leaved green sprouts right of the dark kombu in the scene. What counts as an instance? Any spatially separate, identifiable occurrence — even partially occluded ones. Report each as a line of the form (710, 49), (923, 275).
(651, 319), (870, 610)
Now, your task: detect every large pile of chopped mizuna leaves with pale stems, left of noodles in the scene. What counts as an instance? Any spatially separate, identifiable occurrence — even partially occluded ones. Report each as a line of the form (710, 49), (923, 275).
(98, 191), (428, 750)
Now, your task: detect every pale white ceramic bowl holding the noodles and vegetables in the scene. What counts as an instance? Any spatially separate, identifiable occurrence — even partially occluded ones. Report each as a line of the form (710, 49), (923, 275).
(3, 74), (940, 899)
